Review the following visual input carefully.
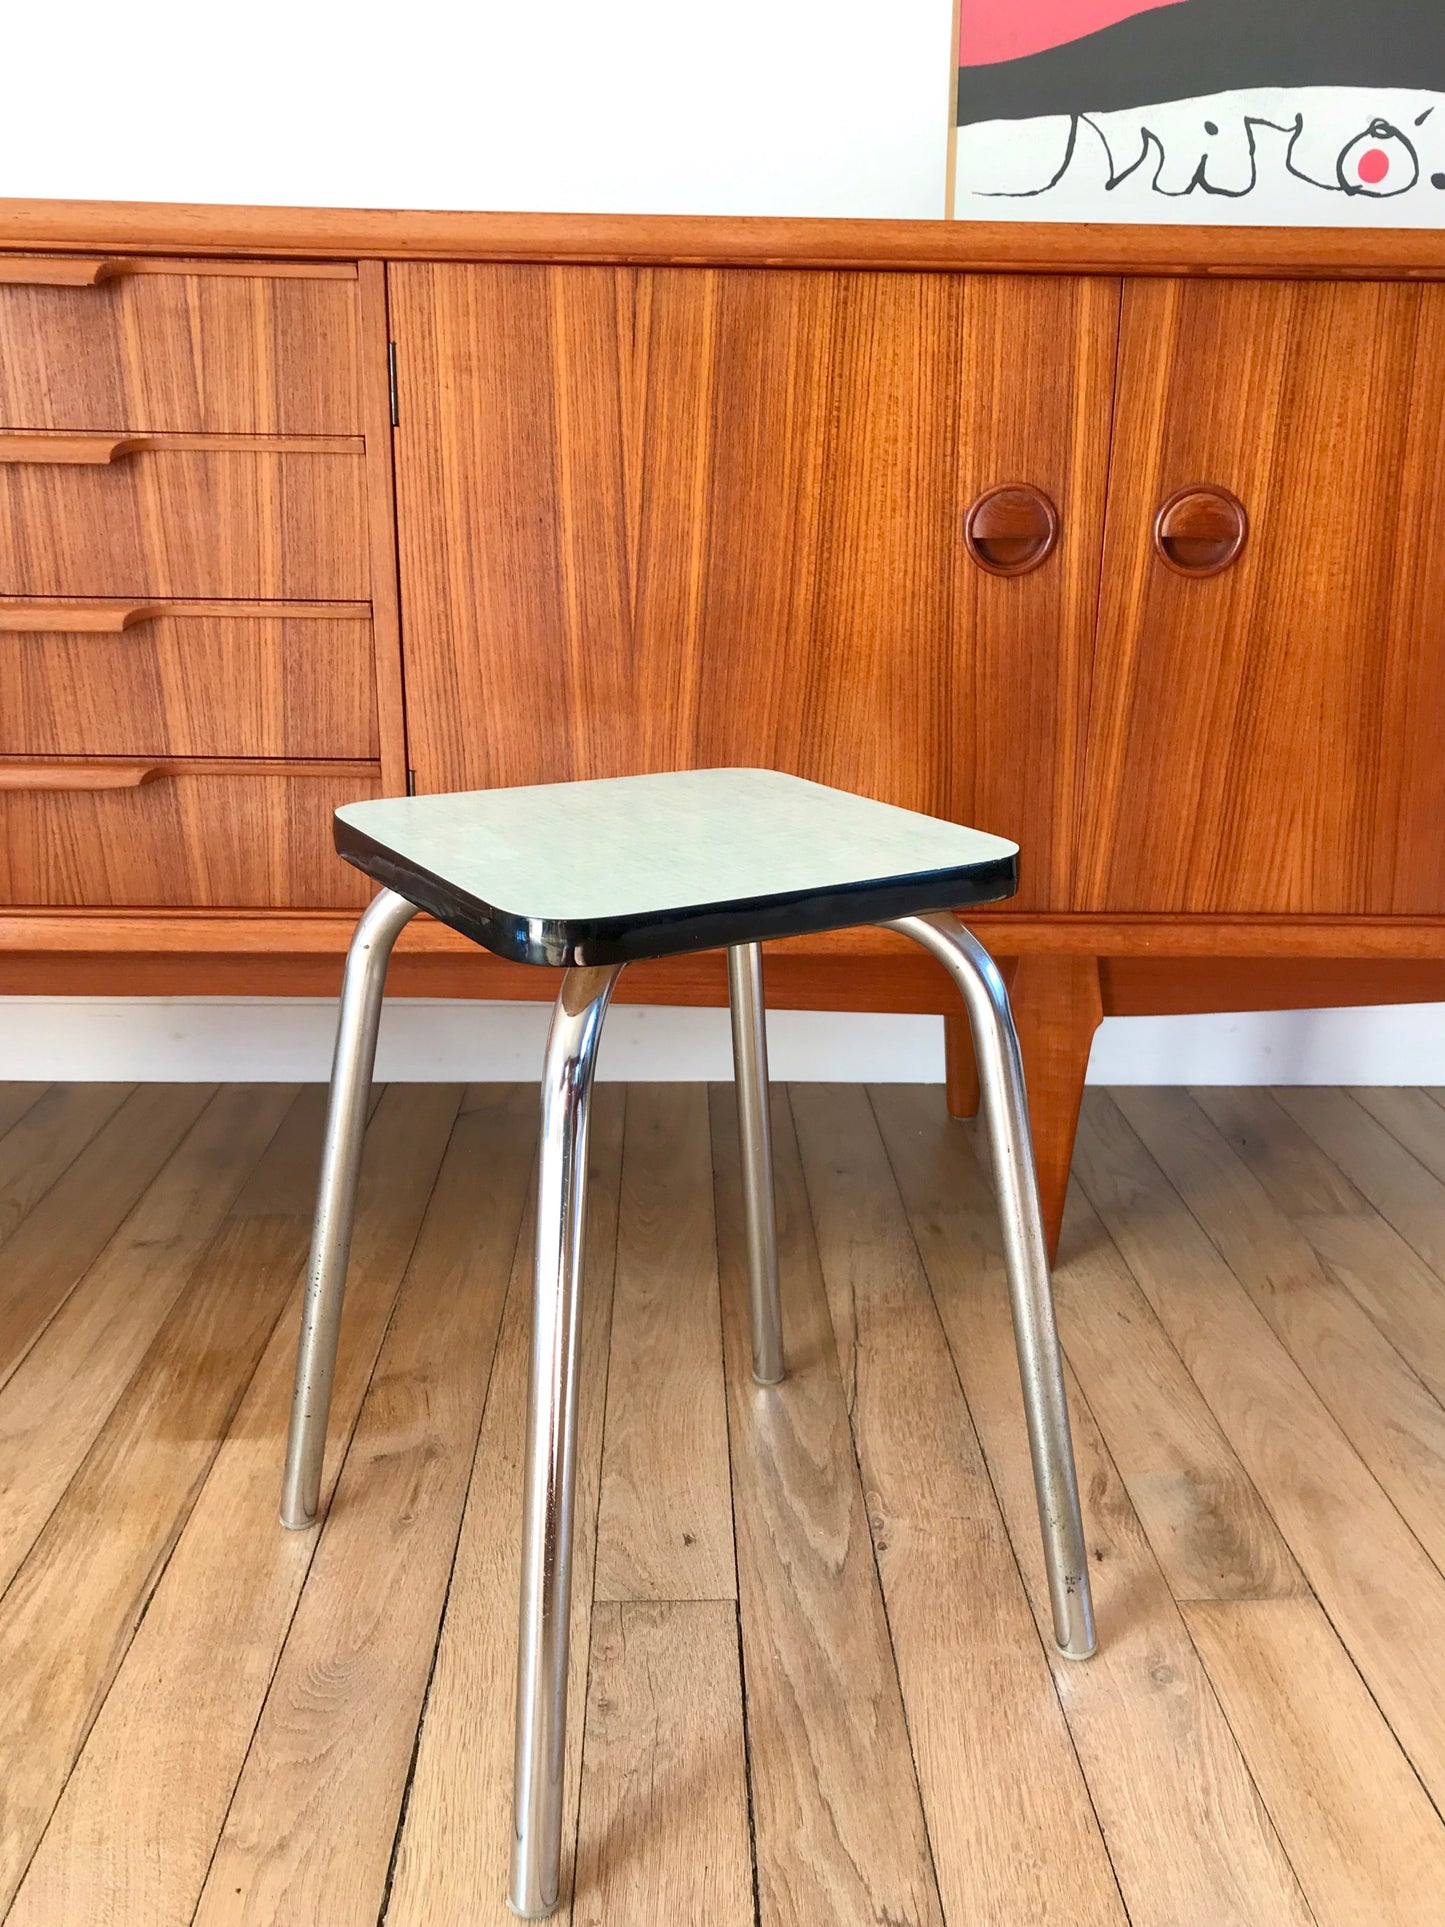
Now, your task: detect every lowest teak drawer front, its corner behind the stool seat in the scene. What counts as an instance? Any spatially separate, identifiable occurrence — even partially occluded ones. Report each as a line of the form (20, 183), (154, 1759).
(0, 763), (381, 910)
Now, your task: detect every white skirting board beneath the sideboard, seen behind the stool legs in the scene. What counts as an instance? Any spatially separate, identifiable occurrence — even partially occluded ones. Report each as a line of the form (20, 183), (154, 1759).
(0, 996), (1445, 1085)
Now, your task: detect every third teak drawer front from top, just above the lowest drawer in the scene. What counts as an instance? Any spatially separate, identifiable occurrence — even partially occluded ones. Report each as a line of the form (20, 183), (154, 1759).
(0, 599), (378, 761)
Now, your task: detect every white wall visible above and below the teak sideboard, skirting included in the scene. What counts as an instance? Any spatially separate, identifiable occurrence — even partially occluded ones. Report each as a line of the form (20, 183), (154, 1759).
(0, 0), (1445, 1083)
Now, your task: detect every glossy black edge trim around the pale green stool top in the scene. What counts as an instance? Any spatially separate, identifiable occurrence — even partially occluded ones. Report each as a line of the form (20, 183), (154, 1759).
(333, 817), (1019, 969)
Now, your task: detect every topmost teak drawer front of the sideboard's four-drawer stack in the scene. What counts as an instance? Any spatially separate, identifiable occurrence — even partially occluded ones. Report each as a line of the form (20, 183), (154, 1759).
(0, 254), (360, 436)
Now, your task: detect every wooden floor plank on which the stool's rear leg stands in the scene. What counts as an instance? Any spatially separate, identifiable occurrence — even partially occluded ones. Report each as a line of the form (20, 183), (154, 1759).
(711, 1085), (940, 1927)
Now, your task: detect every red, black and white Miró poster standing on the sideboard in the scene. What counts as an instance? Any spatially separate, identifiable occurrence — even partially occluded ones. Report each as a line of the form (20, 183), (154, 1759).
(950, 0), (1445, 227)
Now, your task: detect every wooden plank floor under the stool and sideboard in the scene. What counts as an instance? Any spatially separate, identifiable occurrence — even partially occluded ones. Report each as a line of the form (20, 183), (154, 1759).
(0, 1085), (1445, 1927)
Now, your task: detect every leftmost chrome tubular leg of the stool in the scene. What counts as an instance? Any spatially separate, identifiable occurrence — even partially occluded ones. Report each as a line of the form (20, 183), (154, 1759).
(281, 890), (416, 1532)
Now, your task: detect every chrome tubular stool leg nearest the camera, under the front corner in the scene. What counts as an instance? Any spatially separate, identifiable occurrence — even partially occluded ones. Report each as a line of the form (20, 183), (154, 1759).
(507, 965), (622, 1919)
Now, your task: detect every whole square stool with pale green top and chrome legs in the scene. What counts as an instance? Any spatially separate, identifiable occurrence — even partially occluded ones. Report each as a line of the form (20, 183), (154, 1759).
(281, 769), (1094, 1919)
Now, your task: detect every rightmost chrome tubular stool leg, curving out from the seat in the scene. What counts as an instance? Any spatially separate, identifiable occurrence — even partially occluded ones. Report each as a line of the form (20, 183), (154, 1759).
(888, 911), (1094, 1659)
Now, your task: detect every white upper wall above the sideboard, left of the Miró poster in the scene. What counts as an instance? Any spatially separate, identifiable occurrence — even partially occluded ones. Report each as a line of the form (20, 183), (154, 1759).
(0, 0), (952, 216)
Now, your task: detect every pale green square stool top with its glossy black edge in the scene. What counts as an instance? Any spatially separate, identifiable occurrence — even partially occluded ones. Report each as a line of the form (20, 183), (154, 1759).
(335, 769), (1019, 965)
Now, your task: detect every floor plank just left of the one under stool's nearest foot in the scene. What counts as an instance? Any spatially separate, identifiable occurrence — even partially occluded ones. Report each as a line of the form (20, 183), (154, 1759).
(197, 1087), (532, 1921)
